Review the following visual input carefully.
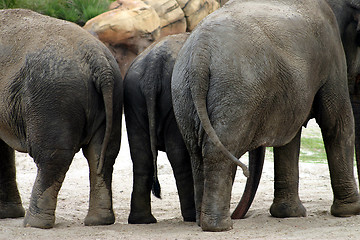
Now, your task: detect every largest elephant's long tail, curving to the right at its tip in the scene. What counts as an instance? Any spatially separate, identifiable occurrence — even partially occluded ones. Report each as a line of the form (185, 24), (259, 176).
(188, 47), (249, 177)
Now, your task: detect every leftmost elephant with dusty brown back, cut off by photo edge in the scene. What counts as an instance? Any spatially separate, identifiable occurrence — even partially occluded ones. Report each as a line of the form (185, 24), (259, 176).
(0, 9), (122, 228)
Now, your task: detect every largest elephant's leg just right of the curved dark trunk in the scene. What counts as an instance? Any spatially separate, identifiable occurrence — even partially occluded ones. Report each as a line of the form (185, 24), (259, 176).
(270, 129), (306, 218)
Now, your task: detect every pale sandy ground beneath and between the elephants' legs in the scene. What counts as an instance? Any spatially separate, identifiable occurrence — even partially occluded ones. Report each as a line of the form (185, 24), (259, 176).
(0, 121), (360, 240)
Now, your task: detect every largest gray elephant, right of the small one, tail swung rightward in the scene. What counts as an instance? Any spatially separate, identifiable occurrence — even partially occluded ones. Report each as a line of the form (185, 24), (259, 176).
(171, 0), (360, 231)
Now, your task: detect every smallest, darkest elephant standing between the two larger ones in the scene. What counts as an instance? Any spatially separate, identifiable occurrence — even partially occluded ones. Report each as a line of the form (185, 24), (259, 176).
(124, 33), (195, 223)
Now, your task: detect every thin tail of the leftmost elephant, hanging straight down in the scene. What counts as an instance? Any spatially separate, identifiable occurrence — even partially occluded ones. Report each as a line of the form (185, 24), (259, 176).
(97, 77), (114, 174)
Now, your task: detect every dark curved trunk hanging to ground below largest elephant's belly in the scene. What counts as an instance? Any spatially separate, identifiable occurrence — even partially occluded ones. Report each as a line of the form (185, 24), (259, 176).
(231, 147), (265, 219)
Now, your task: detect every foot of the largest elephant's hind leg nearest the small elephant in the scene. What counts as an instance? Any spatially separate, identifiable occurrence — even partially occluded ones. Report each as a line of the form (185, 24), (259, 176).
(200, 214), (233, 232)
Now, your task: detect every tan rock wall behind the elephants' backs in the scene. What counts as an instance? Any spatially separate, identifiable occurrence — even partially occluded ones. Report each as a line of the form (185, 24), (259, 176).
(84, 0), (222, 76)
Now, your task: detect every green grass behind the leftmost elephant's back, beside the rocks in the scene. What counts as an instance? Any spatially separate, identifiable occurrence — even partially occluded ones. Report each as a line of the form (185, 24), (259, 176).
(0, 0), (113, 26)
